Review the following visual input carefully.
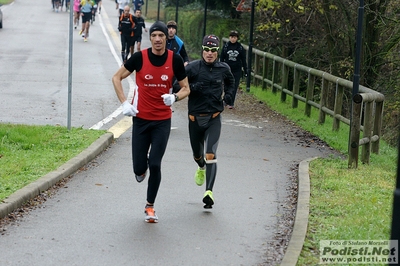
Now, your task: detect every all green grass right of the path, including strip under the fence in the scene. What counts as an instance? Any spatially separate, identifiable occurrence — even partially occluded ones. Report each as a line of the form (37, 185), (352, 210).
(244, 87), (398, 265)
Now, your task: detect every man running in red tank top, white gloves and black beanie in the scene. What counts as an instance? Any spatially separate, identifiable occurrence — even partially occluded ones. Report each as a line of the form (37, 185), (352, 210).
(112, 21), (190, 223)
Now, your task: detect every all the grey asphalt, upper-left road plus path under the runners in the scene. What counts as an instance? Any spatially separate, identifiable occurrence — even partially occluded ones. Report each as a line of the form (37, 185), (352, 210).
(0, 0), (338, 266)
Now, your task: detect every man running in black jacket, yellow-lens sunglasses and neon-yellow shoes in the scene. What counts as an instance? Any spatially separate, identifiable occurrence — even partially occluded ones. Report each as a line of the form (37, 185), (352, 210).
(174, 35), (235, 208)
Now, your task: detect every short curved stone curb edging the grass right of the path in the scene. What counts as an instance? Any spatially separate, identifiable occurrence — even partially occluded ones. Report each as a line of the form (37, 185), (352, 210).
(280, 157), (316, 266)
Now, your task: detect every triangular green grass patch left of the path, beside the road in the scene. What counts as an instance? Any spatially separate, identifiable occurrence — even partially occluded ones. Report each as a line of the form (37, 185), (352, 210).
(0, 124), (105, 202)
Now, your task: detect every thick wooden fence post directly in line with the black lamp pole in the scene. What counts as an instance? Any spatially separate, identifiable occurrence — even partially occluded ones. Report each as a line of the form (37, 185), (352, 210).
(348, 94), (362, 168)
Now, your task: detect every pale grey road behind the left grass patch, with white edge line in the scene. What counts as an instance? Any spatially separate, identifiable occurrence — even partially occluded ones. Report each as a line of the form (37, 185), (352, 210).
(0, 0), (141, 128)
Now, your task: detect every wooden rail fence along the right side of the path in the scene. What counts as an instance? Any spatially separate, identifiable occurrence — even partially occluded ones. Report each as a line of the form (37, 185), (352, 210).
(222, 38), (385, 168)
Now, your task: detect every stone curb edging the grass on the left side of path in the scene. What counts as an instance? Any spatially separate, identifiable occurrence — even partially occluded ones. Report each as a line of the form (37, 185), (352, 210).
(0, 132), (114, 218)
